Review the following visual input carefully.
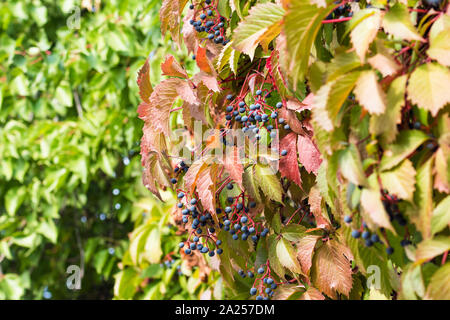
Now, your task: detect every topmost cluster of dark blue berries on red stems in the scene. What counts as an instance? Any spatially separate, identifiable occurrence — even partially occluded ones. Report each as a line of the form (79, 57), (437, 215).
(189, 0), (229, 45)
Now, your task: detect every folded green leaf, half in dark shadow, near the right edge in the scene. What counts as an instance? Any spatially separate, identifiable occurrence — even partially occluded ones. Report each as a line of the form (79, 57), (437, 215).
(380, 130), (428, 171)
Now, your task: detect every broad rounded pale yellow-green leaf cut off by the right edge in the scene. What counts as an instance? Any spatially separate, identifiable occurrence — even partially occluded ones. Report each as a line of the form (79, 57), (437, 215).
(407, 62), (450, 116)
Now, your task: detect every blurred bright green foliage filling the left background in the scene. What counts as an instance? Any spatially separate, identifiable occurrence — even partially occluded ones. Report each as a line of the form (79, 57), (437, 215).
(0, 0), (217, 299)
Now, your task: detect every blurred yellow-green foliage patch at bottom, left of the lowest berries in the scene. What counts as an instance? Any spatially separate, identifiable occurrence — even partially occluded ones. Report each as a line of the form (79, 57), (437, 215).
(114, 191), (223, 300)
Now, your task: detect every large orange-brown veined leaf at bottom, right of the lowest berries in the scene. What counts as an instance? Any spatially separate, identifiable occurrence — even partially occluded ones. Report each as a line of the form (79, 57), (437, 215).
(312, 240), (353, 299)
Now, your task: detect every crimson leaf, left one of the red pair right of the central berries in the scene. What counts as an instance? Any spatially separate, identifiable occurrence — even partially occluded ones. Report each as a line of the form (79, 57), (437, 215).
(280, 132), (302, 186)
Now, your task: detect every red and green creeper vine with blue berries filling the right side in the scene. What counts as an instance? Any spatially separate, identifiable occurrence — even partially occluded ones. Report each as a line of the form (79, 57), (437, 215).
(138, 0), (450, 300)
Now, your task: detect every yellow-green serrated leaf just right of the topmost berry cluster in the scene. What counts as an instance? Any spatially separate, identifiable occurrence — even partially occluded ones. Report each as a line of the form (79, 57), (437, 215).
(233, 2), (284, 60)
